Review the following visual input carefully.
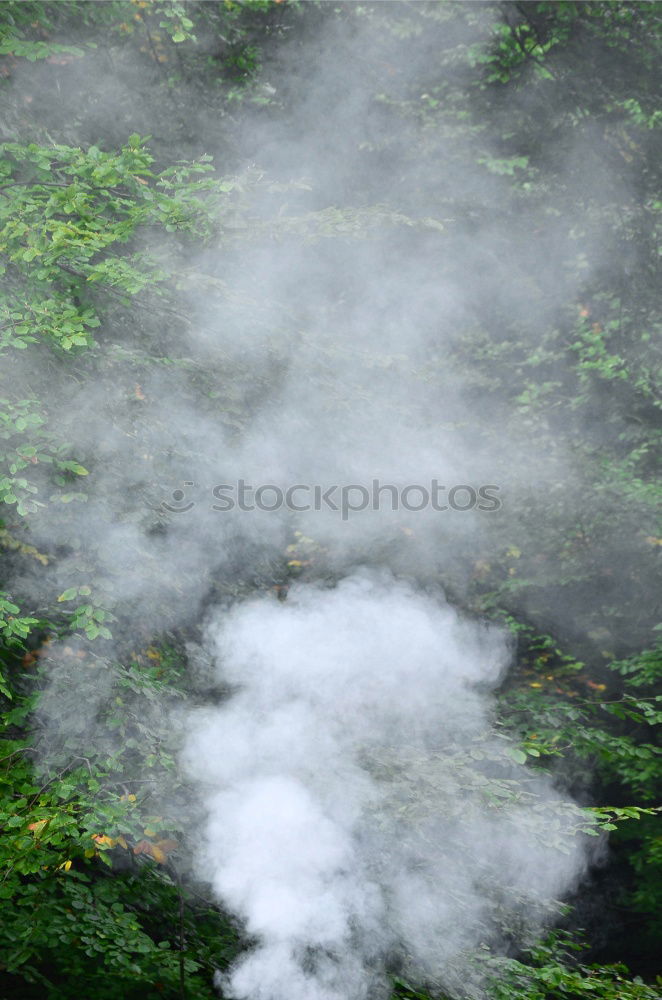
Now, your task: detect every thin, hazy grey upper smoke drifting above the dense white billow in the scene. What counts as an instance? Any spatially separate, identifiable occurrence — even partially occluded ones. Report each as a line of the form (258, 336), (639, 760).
(6, 1), (603, 627)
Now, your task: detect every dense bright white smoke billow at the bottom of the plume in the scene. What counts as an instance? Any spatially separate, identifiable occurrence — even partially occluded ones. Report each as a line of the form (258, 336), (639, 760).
(185, 571), (584, 1000)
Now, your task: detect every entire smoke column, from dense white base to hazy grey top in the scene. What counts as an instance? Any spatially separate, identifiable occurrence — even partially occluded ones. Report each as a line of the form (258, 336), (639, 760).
(2, 5), (640, 1000)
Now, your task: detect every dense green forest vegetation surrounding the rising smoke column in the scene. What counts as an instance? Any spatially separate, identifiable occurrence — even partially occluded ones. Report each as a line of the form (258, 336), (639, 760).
(0, 0), (662, 1000)
